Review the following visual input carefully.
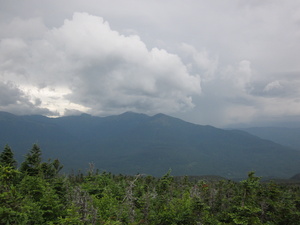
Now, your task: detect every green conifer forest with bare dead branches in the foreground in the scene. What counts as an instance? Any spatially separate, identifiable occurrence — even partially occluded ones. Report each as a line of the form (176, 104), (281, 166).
(0, 145), (300, 225)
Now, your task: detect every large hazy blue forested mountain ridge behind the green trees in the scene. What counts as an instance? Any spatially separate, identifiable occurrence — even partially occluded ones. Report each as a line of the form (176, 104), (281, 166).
(0, 112), (300, 178)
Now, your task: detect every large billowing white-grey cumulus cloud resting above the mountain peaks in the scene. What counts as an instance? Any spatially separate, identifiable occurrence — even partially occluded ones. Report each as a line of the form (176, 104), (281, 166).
(0, 13), (201, 115)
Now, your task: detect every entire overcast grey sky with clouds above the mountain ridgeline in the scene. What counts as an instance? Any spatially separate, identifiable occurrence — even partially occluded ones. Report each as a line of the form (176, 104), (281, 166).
(0, 0), (300, 127)
